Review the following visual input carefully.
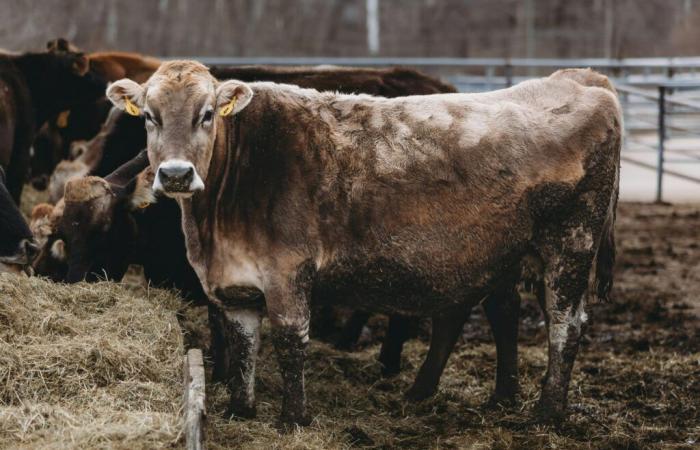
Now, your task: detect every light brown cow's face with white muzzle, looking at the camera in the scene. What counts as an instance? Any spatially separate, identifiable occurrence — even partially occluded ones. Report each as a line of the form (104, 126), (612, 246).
(107, 61), (253, 198)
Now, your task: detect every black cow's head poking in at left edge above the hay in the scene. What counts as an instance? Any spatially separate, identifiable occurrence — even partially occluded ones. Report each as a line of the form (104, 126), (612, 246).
(0, 166), (38, 273)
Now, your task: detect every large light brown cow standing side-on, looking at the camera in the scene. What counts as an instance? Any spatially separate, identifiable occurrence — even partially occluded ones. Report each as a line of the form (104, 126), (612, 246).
(107, 61), (621, 424)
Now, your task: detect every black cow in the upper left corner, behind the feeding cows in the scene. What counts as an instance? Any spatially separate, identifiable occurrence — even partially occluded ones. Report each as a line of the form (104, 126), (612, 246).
(0, 46), (106, 203)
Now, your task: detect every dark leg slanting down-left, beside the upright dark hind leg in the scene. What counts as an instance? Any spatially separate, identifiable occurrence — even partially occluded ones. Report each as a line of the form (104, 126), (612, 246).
(406, 306), (471, 401)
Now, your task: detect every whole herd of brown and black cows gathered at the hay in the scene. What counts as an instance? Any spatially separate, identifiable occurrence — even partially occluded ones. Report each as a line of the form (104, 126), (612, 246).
(0, 39), (622, 425)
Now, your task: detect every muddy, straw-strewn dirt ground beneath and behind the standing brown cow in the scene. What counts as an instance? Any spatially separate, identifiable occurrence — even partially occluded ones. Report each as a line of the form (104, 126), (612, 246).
(178, 203), (700, 449)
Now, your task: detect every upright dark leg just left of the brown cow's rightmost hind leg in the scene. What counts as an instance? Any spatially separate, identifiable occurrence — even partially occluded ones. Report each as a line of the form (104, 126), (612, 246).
(484, 284), (520, 404)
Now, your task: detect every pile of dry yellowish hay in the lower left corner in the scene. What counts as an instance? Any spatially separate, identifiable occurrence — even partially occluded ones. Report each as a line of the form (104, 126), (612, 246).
(0, 274), (183, 449)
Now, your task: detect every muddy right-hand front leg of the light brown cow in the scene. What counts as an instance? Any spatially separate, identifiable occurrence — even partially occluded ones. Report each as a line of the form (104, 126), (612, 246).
(265, 263), (315, 429)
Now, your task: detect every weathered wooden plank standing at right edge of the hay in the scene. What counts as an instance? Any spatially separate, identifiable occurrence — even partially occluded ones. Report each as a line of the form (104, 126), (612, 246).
(183, 348), (207, 450)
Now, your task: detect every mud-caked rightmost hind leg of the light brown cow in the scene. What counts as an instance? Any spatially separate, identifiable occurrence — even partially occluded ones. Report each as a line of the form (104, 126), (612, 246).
(535, 239), (594, 423)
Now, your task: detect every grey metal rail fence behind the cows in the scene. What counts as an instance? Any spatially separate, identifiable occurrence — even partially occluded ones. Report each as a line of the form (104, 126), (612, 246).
(185, 57), (700, 201)
